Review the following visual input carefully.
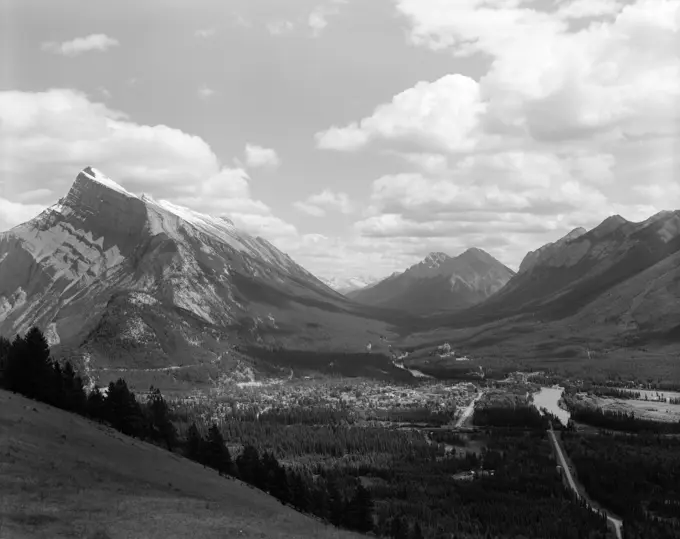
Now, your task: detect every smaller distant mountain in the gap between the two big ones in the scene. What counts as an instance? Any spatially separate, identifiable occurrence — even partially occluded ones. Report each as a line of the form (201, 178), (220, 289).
(349, 248), (514, 313)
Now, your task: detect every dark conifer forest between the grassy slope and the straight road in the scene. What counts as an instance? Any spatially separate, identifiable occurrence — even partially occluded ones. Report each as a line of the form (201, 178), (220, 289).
(0, 329), (608, 539)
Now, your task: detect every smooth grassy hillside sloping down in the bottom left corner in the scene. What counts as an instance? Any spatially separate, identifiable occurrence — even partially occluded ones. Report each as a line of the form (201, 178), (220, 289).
(0, 391), (360, 539)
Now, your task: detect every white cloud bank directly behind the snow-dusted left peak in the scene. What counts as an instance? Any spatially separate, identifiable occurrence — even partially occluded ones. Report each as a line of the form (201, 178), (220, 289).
(0, 89), (296, 241)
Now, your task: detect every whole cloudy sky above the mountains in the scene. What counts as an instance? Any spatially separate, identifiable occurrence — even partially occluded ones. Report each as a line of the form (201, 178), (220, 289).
(0, 0), (680, 279)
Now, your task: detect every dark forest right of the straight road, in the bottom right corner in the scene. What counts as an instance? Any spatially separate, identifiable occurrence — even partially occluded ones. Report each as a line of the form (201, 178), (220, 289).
(562, 432), (680, 539)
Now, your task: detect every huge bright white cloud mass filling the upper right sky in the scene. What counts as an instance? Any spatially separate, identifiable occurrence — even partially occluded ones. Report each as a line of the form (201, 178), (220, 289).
(308, 0), (680, 266)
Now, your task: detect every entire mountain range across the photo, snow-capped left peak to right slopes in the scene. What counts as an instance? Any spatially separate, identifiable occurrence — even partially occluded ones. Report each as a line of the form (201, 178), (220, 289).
(0, 167), (680, 387)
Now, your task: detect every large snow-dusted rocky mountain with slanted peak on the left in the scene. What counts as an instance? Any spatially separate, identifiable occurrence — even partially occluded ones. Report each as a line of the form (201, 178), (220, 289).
(0, 167), (386, 390)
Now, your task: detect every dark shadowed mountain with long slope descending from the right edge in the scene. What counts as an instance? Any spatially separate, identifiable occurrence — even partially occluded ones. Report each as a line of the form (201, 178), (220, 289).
(418, 211), (680, 354)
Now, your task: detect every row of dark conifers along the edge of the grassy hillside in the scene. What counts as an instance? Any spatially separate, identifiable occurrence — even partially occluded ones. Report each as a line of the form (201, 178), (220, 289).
(0, 328), (373, 532)
